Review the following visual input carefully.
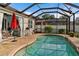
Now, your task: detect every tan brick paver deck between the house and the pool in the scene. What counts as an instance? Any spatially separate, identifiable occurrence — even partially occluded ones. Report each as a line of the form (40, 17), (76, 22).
(0, 34), (42, 56)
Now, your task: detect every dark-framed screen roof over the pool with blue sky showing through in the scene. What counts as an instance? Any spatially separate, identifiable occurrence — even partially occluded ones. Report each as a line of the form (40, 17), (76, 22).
(0, 3), (79, 17)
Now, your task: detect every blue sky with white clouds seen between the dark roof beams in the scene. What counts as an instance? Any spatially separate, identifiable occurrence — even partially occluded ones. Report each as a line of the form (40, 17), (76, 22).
(9, 3), (79, 17)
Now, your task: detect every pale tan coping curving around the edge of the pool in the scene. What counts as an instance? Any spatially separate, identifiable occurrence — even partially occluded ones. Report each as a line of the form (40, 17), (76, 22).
(9, 34), (79, 56)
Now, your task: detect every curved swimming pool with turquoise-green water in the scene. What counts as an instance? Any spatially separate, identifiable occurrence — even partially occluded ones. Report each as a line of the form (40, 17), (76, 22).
(15, 35), (79, 56)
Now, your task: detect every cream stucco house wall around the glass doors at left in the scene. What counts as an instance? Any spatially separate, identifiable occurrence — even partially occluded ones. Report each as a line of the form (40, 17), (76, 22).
(0, 7), (32, 41)
